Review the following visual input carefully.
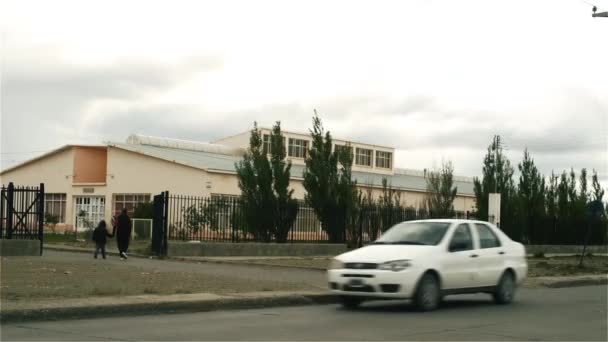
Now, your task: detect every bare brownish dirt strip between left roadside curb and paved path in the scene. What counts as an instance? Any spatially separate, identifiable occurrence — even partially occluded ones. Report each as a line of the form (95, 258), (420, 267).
(0, 257), (318, 301)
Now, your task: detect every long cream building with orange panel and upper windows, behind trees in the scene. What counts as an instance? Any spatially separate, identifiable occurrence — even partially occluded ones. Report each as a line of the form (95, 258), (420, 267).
(0, 128), (475, 229)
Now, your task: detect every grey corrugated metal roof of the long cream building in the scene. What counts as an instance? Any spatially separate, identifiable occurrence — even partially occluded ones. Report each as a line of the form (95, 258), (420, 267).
(109, 143), (474, 196)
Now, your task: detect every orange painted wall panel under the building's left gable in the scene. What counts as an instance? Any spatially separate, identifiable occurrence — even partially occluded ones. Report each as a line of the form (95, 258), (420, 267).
(74, 147), (108, 183)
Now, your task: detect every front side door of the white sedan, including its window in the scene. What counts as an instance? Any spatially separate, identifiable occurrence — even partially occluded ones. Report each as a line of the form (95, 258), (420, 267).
(442, 223), (479, 289)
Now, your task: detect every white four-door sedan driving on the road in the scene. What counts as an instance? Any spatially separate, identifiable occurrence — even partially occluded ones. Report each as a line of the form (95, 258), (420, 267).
(327, 220), (528, 311)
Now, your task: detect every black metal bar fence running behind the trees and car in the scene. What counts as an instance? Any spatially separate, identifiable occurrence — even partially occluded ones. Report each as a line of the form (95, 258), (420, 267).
(155, 192), (608, 248)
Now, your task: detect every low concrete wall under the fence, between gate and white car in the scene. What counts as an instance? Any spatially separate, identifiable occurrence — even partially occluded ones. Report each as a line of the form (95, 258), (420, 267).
(168, 241), (347, 257)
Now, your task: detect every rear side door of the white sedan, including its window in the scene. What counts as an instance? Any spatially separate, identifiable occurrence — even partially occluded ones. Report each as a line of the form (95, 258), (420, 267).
(474, 223), (507, 286)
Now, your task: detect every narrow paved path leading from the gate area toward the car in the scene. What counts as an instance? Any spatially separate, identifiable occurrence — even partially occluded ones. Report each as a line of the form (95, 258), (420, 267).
(36, 250), (327, 290)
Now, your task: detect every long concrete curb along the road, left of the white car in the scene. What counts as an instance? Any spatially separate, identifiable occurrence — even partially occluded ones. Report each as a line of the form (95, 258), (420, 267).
(0, 294), (338, 323)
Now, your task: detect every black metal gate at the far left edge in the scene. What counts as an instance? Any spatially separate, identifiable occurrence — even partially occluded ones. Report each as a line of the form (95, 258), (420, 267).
(0, 183), (44, 255)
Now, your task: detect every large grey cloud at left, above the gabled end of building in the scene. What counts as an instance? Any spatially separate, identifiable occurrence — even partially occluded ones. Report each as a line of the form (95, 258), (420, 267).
(0, 47), (223, 161)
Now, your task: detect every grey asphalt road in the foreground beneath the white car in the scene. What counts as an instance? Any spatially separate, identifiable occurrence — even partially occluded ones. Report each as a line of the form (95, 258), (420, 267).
(0, 286), (608, 341)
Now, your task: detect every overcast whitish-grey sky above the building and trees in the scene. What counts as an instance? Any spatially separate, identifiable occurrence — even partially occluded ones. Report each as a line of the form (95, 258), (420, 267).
(0, 0), (608, 187)
